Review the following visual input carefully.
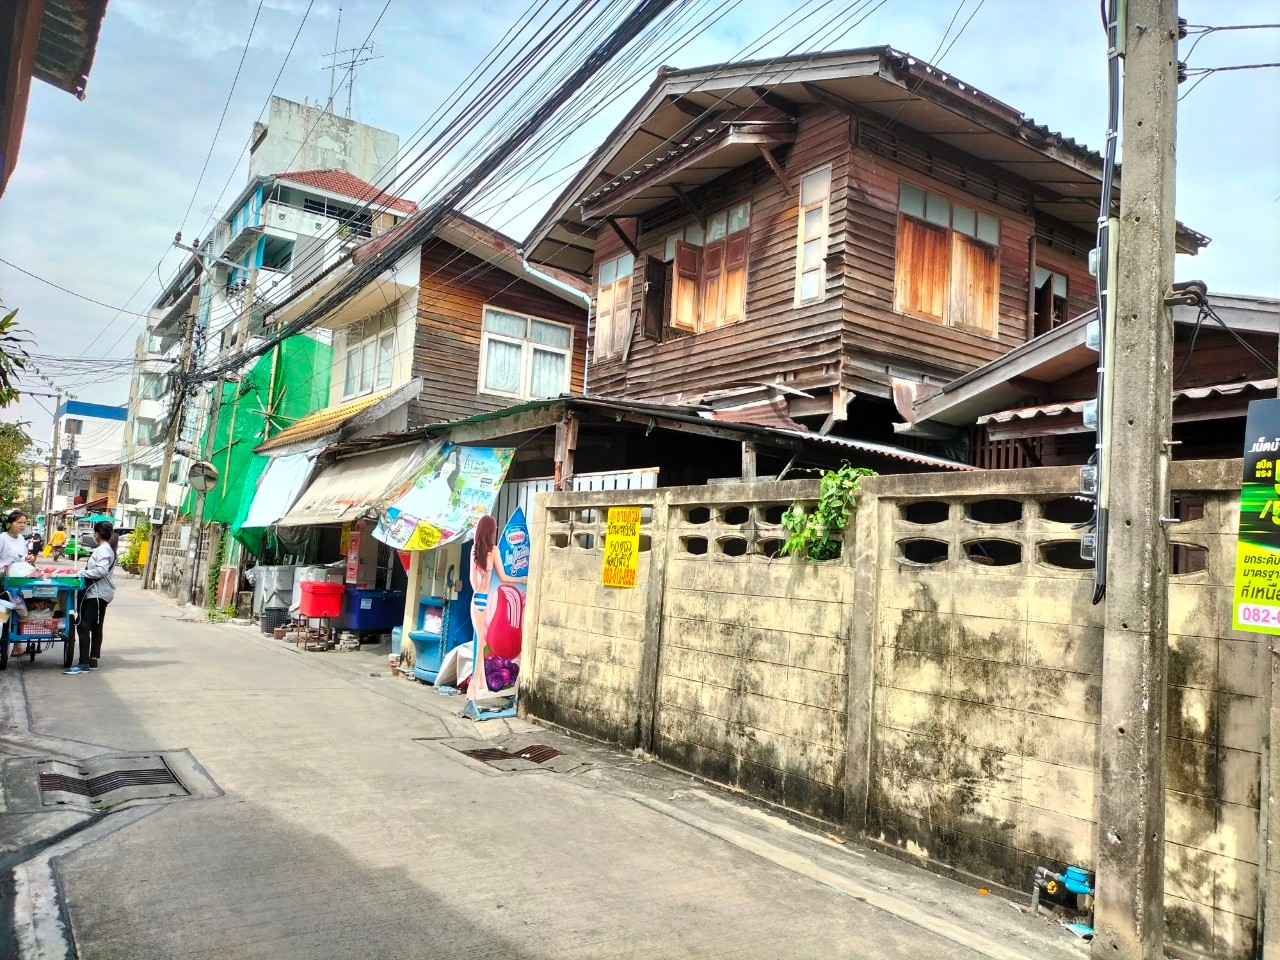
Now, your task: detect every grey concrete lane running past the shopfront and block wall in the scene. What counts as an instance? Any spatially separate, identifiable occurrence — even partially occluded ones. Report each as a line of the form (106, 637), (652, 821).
(0, 582), (1080, 960)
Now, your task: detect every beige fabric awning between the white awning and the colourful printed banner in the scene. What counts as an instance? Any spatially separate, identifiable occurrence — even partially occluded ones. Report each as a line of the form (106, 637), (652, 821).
(276, 440), (434, 526)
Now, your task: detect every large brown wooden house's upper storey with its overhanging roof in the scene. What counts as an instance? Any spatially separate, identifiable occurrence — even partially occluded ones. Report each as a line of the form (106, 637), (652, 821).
(525, 47), (1206, 457)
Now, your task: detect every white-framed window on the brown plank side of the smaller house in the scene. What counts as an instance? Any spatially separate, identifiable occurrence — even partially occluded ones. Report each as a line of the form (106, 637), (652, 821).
(479, 307), (573, 399)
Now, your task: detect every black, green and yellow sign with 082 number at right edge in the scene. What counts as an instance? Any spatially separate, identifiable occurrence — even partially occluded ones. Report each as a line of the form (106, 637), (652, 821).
(1231, 399), (1280, 634)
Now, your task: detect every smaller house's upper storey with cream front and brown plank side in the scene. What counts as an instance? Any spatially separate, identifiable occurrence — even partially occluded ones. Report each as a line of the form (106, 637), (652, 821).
(257, 215), (589, 456)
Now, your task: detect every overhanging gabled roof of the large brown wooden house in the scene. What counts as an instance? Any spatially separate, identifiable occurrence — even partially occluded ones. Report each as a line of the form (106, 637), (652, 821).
(525, 46), (1208, 276)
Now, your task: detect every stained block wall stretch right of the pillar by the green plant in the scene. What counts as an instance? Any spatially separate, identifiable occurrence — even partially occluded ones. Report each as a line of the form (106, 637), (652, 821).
(858, 462), (1272, 959)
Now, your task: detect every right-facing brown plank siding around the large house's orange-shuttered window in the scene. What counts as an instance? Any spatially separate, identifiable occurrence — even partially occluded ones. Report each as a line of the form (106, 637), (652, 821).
(844, 147), (1088, 396)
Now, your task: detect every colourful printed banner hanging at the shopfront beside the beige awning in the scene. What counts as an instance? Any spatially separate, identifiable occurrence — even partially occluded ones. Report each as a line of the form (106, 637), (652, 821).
(374, 443), (515, 550)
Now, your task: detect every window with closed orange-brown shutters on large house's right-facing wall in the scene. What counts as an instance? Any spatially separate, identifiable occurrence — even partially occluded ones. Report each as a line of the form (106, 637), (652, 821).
(893, 183), (1000, 337)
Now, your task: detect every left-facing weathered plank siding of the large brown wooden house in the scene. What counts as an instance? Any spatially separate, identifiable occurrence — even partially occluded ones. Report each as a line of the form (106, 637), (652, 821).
(590, 108), (850, 399)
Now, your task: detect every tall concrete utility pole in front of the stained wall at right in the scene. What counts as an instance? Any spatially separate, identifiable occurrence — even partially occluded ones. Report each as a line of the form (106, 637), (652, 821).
(1092, 0), (1178, 960)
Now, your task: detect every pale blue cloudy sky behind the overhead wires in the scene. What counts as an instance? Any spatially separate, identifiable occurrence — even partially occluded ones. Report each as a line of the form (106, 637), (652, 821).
(0, 0), (1280, 458)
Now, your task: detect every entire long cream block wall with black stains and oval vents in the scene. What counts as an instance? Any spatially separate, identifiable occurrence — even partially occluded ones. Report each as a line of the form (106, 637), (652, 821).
(524, 462), (1280, 959)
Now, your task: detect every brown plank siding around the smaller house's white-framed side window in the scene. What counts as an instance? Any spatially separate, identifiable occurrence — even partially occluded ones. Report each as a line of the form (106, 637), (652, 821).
(410, 241), (586, 426)
